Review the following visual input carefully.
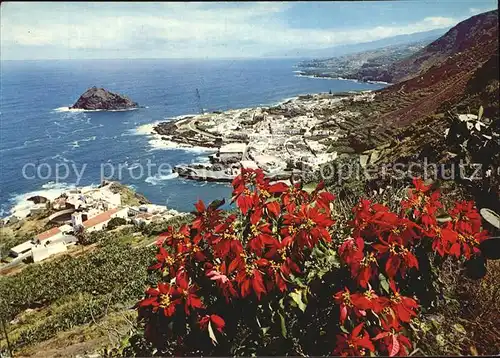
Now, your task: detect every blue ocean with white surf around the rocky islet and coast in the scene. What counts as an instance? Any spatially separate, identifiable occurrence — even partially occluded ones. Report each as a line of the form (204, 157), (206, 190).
(0, 59), (383, 217)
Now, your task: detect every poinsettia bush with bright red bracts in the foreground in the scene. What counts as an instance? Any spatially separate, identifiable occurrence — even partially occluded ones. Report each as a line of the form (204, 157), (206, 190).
(137, 169), (487, 356)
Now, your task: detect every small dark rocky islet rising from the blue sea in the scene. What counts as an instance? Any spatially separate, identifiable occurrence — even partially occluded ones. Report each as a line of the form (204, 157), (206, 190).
(70, 86), (138, 111)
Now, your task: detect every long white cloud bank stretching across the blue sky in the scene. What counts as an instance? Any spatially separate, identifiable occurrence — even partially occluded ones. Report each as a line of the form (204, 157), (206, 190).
(0, 2), (468, 57)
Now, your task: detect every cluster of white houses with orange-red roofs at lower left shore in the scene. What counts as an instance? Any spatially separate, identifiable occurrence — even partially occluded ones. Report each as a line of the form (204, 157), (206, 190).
(4, 186), (179, 265)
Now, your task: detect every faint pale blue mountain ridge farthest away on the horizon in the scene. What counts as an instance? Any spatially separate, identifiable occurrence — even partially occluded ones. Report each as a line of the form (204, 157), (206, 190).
(264, 27), (449, 59)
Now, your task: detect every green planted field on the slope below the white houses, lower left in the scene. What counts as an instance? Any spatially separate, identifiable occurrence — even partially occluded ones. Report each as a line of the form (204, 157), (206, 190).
(0, 216), (191, 351)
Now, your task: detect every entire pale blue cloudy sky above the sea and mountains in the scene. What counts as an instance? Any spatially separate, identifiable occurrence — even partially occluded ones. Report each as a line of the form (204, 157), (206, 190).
(0, 0), (498, 60)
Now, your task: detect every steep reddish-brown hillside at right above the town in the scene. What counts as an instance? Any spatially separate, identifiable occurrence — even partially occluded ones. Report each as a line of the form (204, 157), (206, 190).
(322, 11), (498, 150)
